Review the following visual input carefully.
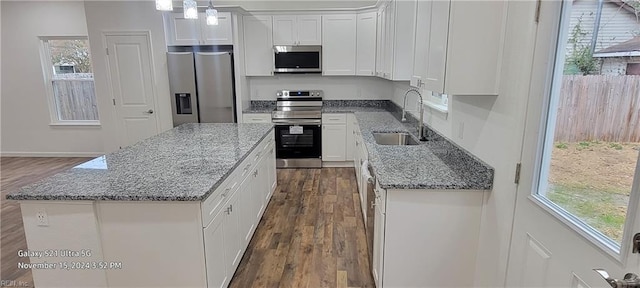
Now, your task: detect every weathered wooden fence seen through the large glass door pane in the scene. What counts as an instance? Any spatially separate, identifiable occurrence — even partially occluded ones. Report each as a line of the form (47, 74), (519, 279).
(555, 75), (640, 142)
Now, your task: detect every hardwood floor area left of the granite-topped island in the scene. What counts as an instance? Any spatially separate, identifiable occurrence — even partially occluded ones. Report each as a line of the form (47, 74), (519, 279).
(0, 157), (91, 287)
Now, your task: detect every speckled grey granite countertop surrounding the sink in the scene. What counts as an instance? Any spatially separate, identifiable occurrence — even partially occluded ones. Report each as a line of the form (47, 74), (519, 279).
(354, 109), (493, 190)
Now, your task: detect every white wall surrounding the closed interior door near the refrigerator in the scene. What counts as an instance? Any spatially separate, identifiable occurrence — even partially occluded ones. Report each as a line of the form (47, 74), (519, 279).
(84, 1), (173, 152)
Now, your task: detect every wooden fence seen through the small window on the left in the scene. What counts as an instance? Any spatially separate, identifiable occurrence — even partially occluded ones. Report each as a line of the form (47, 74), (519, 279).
(53, 79), (98, 120)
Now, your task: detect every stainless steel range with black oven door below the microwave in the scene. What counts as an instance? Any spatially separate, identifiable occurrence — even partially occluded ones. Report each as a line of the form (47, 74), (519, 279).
(271, 90), (323, 168)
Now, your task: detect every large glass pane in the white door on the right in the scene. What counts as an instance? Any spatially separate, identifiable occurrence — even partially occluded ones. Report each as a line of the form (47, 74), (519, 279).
(532, 1), (640, 254)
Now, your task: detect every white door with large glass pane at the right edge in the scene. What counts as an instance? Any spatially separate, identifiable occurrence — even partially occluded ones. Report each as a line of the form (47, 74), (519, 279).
(506, 1), (640, 287)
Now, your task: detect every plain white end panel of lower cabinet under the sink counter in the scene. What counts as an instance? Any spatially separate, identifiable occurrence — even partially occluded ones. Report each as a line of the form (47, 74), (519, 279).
(372, 188), (489, 287)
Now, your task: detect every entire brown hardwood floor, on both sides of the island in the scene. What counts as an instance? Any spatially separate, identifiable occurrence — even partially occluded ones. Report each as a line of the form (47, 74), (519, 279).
(0, 157), (374, 288)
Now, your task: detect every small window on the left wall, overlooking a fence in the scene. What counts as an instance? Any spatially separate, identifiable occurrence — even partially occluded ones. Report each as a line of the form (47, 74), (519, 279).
(40, 37), (100, 125)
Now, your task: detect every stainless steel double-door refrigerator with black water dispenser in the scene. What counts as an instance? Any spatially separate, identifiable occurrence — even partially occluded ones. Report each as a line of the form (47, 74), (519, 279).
(167, 52), (236, 126)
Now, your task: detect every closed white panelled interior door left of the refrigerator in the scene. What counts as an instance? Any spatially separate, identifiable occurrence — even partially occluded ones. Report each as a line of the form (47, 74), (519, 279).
(105, 32), (158, 147)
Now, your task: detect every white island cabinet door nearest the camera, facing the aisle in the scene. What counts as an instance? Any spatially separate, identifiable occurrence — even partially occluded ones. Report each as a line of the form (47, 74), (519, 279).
(204, 208), (231, 288)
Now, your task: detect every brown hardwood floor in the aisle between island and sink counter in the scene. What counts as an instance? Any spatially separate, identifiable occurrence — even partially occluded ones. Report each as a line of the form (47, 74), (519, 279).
(230, 168), (374, 288)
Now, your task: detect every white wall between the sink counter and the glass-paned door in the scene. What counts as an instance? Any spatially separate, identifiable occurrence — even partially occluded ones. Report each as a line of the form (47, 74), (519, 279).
(392, 1), (535, 287)
